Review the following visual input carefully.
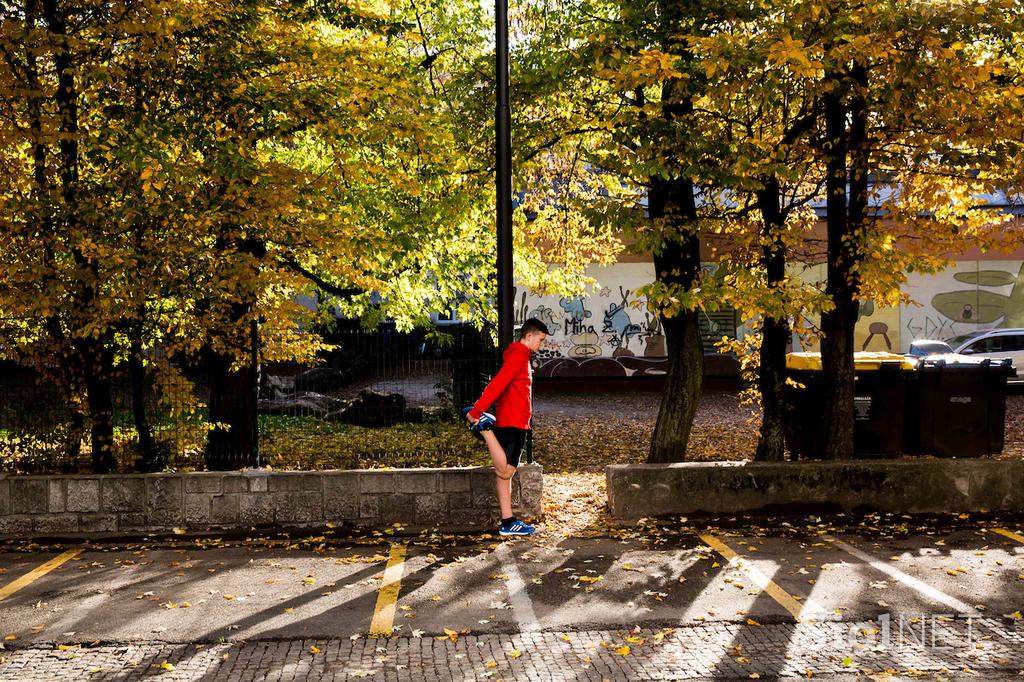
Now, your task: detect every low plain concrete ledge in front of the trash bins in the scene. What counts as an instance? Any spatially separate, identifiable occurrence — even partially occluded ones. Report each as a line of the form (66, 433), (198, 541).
(606, 460), (1024, 522)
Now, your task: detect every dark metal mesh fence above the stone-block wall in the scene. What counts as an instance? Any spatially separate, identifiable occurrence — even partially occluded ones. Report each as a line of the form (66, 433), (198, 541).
(0, 321), (495, 473)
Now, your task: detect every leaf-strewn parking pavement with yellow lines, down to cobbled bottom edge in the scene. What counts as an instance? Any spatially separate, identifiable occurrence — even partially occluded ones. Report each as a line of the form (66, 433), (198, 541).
(0, 518), (1024, 680)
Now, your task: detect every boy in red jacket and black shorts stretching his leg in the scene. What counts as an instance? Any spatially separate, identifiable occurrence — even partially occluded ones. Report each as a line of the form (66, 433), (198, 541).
(466, 317), (548, 536)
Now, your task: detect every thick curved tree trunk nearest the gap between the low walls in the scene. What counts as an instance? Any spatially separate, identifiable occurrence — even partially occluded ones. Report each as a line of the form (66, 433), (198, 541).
(647, 178), (703, 463)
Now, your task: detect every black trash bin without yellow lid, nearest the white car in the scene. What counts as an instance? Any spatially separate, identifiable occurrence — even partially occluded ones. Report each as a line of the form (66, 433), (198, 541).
(907, 358), (1017, 457)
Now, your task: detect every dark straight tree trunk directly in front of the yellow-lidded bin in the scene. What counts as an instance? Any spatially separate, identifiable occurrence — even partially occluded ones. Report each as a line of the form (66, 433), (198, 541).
(821, 65), (867, 460)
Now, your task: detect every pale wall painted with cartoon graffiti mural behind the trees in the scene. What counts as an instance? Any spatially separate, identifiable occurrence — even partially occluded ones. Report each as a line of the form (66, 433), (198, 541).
(516, 260), (1024, 377)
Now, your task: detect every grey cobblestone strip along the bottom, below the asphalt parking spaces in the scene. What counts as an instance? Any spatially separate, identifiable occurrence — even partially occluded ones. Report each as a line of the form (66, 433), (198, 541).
(0, 619), (1024, 682)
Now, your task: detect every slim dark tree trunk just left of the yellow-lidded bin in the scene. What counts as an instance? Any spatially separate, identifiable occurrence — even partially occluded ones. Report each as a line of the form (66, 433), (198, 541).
(754, 177), (790, 461)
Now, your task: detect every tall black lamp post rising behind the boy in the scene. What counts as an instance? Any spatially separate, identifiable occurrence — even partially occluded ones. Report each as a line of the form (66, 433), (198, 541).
(495, 0), (515, 350)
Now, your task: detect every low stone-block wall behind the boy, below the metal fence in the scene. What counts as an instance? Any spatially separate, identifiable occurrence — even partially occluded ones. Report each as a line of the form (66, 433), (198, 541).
(0, 465), (543, 537)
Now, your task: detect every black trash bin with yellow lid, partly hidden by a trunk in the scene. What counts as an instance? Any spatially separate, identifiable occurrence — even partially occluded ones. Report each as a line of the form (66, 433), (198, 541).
(785, 352), (915, 459)
